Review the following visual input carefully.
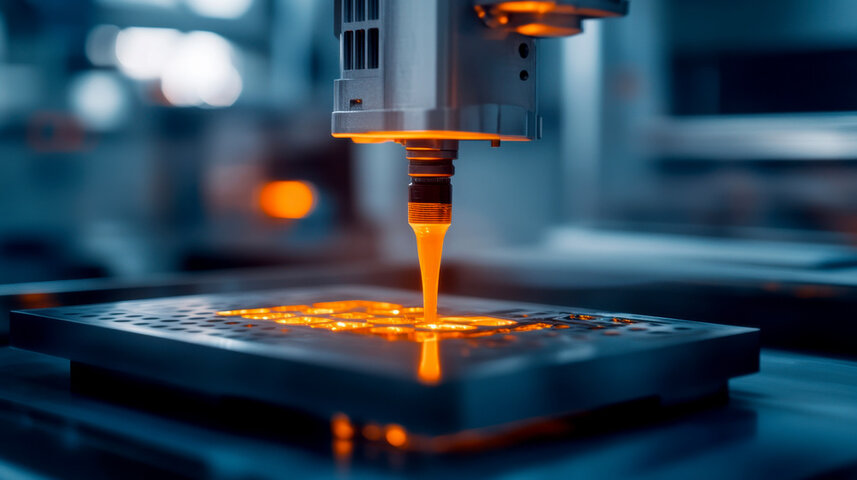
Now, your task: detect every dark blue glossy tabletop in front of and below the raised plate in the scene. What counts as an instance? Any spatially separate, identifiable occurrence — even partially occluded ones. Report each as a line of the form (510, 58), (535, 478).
(0, 348), (857, 480)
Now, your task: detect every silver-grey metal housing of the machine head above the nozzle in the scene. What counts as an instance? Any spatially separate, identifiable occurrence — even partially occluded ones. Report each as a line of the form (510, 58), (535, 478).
(332, 0), (538, 141)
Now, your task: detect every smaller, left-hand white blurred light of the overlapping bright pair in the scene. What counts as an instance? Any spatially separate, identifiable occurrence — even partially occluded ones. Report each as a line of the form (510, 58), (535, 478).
(116, 27), (182, 80)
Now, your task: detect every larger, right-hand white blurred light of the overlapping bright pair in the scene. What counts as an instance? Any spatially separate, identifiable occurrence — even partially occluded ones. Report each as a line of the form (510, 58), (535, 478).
(161, 32), (242, 107)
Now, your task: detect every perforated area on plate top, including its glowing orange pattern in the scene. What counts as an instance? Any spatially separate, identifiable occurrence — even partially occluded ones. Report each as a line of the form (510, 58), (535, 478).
(36, 291), (704, 348)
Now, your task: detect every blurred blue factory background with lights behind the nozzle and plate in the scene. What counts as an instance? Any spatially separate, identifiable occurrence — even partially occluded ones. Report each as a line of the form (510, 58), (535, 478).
(0, 0), (857, 352)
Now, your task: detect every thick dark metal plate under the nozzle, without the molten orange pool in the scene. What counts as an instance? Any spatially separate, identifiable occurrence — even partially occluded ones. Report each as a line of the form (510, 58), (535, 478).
(11, 286), (758, 435)
